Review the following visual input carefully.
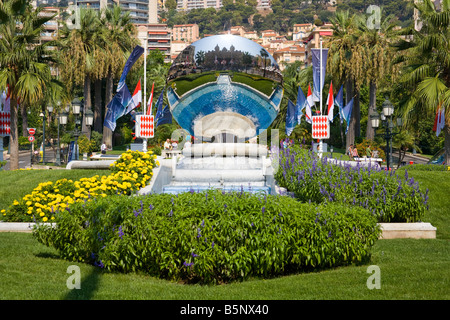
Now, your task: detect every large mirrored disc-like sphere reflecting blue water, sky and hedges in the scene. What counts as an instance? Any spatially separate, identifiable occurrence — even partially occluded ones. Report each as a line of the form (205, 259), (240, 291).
(166, 34), (283, 142)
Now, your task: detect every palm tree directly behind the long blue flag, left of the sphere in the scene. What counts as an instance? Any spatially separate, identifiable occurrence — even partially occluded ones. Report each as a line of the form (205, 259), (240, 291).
(100, 5), (138, 147)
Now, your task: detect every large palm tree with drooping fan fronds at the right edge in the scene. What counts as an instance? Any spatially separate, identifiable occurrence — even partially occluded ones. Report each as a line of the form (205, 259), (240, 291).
(397, 0), (450, 164)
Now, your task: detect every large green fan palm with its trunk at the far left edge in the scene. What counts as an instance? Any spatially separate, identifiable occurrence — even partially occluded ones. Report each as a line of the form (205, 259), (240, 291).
(0, 0), (57, 170)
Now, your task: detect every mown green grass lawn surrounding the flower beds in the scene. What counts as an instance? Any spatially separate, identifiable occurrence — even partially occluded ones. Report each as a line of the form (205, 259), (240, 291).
(0, 170), (450, 301)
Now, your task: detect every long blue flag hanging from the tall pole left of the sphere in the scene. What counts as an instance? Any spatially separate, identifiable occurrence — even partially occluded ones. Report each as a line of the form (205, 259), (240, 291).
(103, 46), (144, 131)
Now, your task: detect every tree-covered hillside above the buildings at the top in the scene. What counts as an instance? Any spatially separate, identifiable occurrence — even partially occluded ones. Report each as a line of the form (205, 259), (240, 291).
(160, 0), (413, 35)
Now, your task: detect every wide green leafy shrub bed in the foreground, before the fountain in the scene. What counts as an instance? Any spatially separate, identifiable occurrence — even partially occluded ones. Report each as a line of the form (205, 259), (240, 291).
(33, 190), (380, 283)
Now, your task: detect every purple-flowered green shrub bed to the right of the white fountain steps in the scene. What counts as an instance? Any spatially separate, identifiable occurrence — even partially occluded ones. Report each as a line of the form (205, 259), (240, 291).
(275, 147), (428, 222)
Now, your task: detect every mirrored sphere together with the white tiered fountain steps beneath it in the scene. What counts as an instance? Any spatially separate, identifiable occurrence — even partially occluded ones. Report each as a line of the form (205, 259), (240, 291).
(141, 35), (283, 194)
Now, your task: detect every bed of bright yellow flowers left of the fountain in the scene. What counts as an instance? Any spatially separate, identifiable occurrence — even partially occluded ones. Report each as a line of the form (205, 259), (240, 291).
(1, 150), (159, 222)
